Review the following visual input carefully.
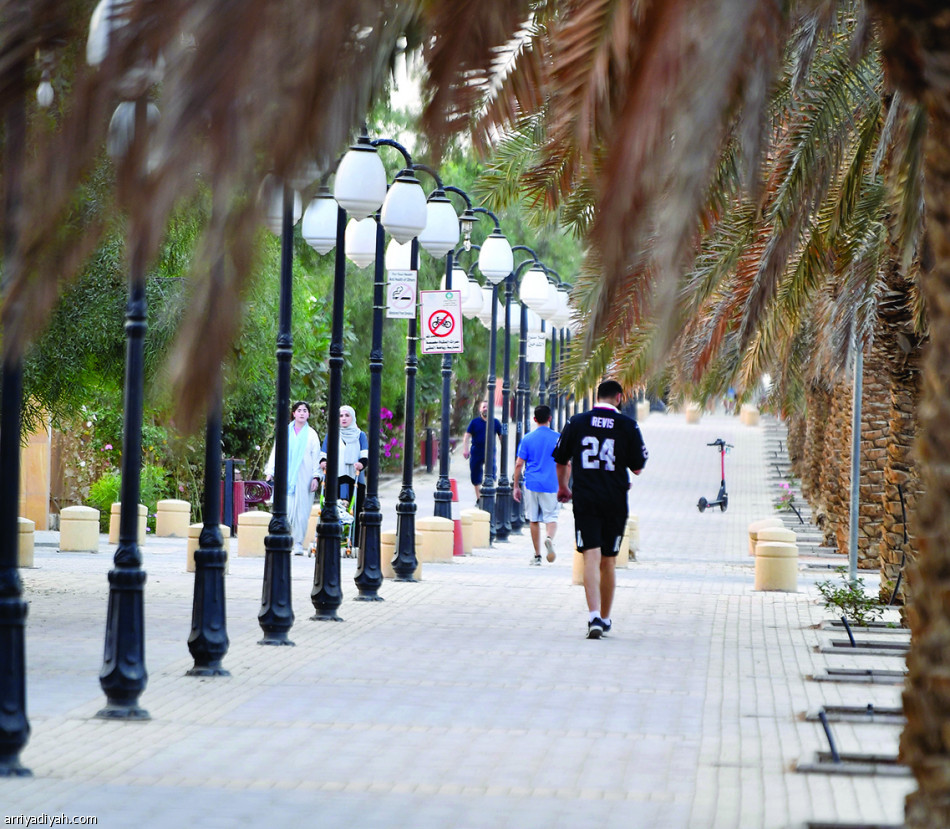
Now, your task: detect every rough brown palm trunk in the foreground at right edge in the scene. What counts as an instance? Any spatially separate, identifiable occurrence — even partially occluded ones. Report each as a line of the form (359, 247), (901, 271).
(872, 0), (950, 829)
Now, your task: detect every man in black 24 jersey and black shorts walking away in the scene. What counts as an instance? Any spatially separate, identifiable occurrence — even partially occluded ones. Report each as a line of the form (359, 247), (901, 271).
(554, 380), (647, 639)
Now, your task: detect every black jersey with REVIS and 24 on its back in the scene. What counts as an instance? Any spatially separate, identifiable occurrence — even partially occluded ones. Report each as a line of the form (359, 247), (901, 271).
(554, 406), (647, 504)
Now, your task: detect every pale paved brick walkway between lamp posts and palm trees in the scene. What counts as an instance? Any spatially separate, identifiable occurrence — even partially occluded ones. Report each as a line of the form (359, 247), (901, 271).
(0, 414), (912, 829)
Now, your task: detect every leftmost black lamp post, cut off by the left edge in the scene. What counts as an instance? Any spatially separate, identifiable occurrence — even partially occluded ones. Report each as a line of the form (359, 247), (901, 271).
(0, 35), (32, 777)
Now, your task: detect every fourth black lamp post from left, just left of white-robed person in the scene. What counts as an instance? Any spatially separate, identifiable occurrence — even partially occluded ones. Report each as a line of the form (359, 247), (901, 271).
(257, 183), (296, 645)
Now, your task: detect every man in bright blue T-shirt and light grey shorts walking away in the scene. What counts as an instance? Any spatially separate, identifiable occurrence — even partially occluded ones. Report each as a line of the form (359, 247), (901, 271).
(511, 406), (560, 565)
